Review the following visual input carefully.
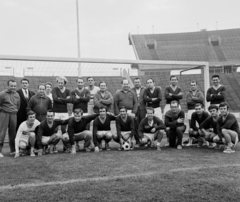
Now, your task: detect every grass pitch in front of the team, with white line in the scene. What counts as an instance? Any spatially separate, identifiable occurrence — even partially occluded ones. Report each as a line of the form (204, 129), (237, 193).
(0, 137), (240, 202)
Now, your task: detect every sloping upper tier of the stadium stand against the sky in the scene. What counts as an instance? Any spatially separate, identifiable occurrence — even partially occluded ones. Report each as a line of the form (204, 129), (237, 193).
(129, 28), (240, 66)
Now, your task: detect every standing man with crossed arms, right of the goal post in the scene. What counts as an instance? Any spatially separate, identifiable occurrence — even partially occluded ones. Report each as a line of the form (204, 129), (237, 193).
(207, 74), (226, 106)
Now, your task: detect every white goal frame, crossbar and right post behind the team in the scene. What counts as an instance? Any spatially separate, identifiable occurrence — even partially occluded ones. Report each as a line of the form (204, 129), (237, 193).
(0, 55), (210, 109)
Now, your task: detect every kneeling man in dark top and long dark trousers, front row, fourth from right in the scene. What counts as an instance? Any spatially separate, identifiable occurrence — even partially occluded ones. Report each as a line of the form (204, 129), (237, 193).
(165, 100), (186, 149)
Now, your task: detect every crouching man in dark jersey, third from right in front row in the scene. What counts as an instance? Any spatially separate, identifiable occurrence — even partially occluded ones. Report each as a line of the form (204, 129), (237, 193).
(186, 103), (209, 147)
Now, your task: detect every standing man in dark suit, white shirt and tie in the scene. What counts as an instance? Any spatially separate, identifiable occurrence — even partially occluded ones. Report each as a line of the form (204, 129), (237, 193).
(16, 78), (35, 130)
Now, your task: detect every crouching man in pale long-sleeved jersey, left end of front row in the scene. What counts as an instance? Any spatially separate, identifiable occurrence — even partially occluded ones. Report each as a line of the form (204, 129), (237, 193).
(15, 111), (40, 158)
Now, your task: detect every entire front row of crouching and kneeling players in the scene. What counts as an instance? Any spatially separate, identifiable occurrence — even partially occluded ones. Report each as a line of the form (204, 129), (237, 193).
(15, 101), (240, 157)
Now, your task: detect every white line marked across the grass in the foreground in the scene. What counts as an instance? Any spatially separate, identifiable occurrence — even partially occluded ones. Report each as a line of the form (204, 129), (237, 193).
(0, 164), (240, 191)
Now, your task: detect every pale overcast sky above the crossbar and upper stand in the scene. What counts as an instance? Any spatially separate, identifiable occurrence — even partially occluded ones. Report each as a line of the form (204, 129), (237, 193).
(0, 0), (240, 59)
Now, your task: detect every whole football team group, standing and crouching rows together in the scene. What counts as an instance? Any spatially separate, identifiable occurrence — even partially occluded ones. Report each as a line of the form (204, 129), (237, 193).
(0, 75), (240, 158)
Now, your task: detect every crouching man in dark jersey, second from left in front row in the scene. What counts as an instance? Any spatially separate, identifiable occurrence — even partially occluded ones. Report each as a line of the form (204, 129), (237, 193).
(36, 110), (68, 156)
